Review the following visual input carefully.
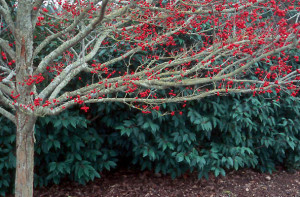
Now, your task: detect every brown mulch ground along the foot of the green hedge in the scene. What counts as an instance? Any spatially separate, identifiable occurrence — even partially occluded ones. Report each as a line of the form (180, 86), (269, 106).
(34, 169), (300, 197)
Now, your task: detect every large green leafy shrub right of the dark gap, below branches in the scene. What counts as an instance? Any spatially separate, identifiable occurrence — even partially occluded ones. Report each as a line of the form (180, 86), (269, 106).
(115, 93), (300, 177)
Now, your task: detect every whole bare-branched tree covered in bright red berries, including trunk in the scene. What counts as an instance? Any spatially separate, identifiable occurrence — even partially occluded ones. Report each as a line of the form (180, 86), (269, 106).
(0, 0), (300, 197)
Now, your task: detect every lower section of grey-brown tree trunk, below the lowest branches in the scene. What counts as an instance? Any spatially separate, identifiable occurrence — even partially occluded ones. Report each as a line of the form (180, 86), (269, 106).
(15, 111), (36, 197)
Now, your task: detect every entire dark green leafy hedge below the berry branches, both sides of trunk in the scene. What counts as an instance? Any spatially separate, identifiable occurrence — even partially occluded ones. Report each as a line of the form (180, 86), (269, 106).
(0, 92), (300, 195)
